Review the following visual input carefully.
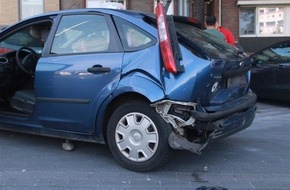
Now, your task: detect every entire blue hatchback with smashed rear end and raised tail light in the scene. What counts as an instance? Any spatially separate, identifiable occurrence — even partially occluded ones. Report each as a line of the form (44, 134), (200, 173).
(0, 5), (256, 172)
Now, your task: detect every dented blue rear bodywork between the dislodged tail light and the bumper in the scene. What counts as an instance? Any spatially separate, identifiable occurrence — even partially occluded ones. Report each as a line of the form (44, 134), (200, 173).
(164, 45), (251, 109)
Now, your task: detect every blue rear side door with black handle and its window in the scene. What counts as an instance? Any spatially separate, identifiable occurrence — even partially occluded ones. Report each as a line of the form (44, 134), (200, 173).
(35, 14), (123, 133)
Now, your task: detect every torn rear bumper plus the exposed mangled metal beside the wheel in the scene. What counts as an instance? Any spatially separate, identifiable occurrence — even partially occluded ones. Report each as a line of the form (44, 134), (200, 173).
(152, 92), (256, 154)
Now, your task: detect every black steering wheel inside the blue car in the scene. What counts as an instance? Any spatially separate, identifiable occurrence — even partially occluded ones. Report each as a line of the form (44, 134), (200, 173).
(15, 47), (38, 75)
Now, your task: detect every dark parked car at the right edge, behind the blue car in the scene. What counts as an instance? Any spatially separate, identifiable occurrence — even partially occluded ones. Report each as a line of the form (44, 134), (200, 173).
(251, 41), (290, 99)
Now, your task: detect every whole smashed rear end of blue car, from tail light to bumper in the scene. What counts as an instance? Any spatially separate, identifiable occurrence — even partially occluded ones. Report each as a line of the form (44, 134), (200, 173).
(151, 1), (257, 154)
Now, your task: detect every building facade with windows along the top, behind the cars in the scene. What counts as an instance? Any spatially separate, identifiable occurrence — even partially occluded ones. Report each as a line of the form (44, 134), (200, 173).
(0, 0), (290, 52)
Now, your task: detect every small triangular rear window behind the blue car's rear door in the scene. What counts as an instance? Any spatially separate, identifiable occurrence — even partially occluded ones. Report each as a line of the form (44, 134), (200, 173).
(114, 17), (157, 51)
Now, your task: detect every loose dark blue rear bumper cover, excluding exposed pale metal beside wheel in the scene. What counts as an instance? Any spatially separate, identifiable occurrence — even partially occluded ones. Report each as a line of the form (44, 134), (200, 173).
(169, 91), (257, 154)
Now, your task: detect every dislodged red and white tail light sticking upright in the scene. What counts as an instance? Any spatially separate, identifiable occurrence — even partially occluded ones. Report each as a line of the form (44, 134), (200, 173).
(155, 2), (177, 73)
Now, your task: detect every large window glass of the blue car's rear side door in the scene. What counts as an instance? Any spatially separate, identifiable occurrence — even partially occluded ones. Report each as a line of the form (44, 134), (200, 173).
(51, 15), (111, 54)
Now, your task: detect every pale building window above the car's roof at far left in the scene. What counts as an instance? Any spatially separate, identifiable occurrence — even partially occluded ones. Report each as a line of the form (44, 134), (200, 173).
(19, 0), (44, 19)
